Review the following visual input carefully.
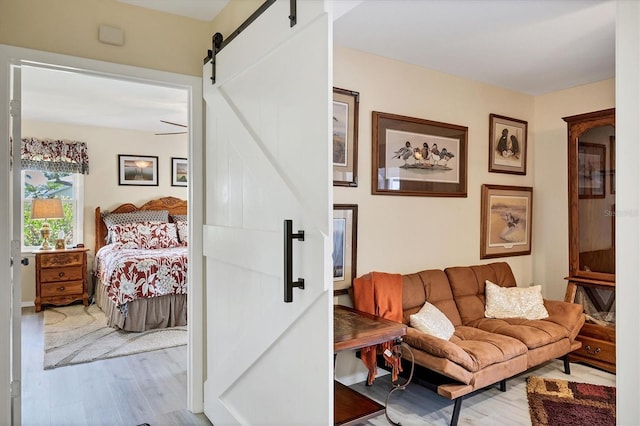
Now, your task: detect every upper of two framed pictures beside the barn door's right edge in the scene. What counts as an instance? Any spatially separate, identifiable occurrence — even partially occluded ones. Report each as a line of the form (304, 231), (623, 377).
(333, 87), (360, 187)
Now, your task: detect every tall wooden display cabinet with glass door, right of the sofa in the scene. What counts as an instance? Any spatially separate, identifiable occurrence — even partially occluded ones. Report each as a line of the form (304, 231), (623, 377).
(564, 109), (616, 373)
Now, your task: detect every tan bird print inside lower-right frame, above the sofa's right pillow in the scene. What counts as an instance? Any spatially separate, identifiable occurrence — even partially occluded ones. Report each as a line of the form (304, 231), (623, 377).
(489, 196), (529, 247)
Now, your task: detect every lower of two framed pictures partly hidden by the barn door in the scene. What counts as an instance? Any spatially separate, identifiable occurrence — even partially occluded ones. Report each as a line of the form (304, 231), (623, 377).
(333, 204), (358, 295)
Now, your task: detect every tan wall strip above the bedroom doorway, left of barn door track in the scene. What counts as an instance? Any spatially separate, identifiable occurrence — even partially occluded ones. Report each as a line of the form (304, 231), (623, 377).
(0, 0), (211, 76)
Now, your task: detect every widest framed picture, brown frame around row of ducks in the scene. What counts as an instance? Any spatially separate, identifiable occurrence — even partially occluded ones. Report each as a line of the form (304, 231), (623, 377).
(371, 111), (468, 197)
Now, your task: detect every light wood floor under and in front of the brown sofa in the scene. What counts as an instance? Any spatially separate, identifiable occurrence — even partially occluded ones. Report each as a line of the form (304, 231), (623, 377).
(351, 360), (616, 426)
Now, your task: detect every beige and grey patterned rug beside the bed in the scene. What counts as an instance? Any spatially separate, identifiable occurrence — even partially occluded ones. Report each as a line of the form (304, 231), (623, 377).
(44, 305), (187, 370)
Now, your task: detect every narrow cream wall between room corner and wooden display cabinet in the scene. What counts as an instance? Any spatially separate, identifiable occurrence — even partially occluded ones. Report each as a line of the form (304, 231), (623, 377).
(533, 79), (615, 300)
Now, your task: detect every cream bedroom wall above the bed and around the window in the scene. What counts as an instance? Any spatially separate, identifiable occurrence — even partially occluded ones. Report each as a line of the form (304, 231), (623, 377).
(22, 120), (188, 304)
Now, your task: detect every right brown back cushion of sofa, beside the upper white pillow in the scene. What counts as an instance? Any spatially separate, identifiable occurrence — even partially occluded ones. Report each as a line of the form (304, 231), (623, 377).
(444, 262), (516, 325)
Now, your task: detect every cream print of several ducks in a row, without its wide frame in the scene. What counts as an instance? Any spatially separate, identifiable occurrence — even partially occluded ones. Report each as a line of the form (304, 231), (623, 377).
(386, 130), (459, 183)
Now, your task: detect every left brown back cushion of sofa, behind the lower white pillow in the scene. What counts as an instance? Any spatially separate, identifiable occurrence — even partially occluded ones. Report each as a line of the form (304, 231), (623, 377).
(402, 269), (462, 326)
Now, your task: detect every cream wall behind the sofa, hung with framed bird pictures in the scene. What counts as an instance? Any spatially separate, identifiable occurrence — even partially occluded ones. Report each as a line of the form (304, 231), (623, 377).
(334, 46), (542, 303)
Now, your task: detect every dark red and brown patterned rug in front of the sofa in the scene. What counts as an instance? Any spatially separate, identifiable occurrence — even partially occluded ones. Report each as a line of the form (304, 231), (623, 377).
(527, 377), (616, 426)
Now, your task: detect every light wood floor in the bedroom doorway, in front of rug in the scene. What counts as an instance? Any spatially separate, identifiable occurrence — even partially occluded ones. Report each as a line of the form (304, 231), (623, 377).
(22, 308), (211, 426)
